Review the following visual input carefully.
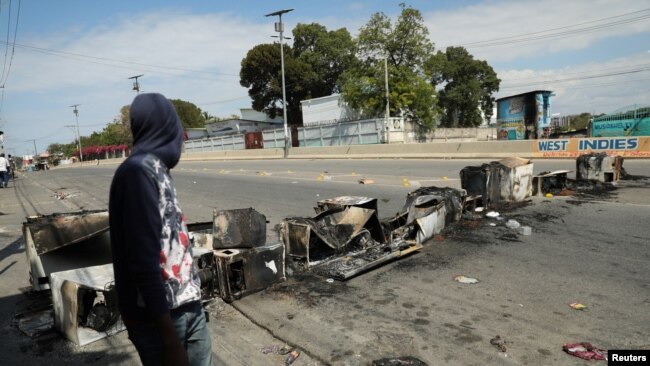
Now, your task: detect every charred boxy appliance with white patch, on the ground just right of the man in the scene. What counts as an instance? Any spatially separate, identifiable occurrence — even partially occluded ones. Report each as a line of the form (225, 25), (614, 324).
(214, 243), (286, 302)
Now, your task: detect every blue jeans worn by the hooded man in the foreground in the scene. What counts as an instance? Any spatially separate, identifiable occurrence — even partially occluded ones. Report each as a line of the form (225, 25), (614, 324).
(127, 301), (213, 366)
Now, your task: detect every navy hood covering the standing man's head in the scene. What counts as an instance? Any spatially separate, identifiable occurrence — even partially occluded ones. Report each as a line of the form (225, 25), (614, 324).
(130, 93), (183, 169)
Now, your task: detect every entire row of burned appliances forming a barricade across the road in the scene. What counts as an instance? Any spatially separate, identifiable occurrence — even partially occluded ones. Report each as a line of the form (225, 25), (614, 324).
(18, 155), (622, 345)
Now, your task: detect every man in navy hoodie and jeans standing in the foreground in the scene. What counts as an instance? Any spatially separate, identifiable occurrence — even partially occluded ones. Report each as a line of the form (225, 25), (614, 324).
(109, 93), (212, 366)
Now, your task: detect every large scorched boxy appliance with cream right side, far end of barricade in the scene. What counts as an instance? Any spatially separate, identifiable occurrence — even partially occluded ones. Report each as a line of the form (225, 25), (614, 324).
(460, 158), (533, 207)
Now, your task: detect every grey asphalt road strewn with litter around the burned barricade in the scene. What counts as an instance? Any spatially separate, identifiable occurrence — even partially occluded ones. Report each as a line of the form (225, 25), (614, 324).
(0, 159), (650, 365)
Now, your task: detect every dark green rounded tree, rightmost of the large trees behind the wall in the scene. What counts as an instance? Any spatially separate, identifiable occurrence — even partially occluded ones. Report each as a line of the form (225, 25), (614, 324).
(427, 47), (501, 127)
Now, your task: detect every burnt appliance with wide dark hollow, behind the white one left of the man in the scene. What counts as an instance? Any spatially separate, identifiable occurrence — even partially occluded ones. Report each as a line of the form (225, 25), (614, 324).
(22, 210), (112, 291)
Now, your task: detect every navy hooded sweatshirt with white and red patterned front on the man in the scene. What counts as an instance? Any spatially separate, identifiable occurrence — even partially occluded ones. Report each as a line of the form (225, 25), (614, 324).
(108, 94), (200, 325)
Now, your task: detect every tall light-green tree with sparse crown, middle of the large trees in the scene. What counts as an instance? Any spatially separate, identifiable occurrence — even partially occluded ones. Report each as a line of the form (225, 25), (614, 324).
(342, 4), (437, 127)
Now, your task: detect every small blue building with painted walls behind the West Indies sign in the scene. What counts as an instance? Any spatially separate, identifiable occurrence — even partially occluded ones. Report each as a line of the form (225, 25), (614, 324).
(497, 90), (555, 140)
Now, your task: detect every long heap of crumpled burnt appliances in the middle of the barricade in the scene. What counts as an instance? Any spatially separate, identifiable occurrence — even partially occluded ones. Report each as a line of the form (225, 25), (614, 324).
(280, 187), (466, 280)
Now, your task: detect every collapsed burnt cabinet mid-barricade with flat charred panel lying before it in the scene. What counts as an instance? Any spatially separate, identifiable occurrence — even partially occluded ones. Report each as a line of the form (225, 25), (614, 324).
(280, 196), (430, 280)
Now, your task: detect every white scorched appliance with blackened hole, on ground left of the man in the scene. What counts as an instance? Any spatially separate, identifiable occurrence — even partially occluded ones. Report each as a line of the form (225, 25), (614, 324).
(51, 264), (125, 346)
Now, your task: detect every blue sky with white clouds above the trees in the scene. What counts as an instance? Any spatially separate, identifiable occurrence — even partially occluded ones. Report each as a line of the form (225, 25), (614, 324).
(0, 0), (650, 155)
